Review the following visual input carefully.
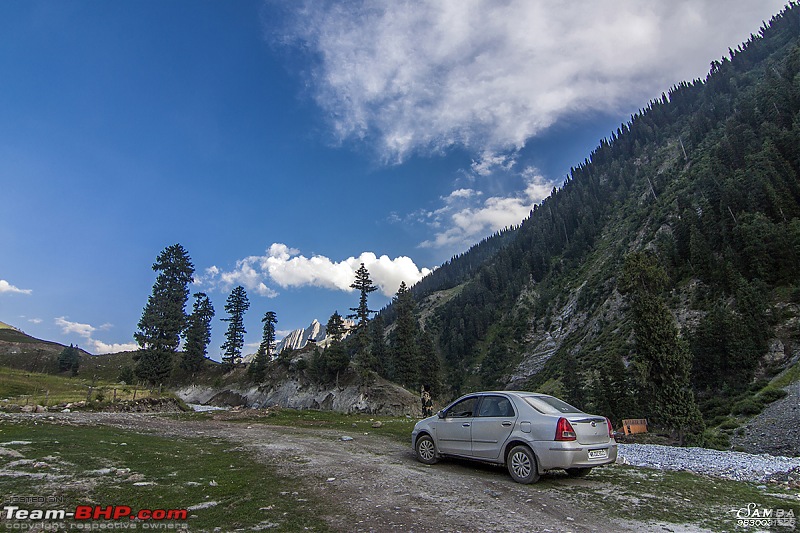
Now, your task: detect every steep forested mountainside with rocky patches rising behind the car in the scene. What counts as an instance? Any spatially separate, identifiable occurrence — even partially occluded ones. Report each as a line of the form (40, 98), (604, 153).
(386, 4), (800, 428)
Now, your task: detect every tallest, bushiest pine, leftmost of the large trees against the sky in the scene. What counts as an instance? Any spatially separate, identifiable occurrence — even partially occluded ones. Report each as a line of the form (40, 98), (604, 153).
(133, 244), (194, 384)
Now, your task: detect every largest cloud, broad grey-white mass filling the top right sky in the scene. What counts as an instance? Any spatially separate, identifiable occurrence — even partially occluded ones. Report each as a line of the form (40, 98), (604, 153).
(278, 0), (785, 162)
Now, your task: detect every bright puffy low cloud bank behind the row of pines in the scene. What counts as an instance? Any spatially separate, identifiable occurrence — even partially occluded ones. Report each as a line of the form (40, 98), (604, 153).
(206, 243), (430, 297)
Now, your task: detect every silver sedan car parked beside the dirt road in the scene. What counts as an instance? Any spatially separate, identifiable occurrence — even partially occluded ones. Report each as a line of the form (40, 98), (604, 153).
(411, 391), (617, 483)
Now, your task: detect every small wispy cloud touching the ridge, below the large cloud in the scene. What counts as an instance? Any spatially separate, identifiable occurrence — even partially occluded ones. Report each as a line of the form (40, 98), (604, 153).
(420, 167), (554, 248)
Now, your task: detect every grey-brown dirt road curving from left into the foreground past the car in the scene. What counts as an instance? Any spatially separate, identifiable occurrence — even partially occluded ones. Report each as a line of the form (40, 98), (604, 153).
(14, 413), (648, 532)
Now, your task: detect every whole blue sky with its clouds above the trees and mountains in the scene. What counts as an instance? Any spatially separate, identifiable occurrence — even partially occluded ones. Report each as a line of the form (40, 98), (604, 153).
(0, 0), (784, 358)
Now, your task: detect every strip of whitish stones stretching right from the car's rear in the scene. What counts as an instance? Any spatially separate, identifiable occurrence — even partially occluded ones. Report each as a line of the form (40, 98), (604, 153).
(617, 444), (800, 483)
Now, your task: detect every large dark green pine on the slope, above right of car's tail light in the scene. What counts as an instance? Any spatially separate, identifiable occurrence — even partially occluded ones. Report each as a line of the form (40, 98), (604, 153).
(619, 252), (702, 444)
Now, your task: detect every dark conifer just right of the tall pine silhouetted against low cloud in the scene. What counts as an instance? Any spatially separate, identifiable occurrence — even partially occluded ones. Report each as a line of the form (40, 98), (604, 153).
(392, 282), (420, 389)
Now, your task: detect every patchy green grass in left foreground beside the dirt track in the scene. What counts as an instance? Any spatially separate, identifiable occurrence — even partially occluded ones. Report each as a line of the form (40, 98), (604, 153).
(0, 421), (328, 531)
